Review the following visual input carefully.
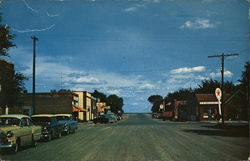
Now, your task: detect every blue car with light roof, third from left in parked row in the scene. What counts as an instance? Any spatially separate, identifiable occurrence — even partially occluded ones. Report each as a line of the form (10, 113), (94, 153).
(55, 114), (78, 135)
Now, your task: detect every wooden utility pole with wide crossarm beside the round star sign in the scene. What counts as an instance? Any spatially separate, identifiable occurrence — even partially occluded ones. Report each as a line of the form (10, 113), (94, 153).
(208, 53), (239, 124)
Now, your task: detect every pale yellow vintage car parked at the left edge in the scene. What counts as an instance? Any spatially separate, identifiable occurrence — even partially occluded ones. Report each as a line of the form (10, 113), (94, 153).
(0, 114), (41, 152)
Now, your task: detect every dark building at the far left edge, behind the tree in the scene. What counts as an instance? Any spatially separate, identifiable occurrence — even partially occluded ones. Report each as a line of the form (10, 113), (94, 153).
(0, 59), (14, 114)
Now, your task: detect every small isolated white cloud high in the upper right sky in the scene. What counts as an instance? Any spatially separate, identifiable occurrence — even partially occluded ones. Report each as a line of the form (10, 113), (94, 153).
(180, 18), (216, 29)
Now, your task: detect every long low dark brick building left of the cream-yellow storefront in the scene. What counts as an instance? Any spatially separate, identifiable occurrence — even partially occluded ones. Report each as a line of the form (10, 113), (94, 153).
(12, 92), (81, 117)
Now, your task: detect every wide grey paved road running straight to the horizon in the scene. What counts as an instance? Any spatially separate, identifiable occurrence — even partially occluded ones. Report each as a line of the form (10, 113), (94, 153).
(1, 114), (248, 161)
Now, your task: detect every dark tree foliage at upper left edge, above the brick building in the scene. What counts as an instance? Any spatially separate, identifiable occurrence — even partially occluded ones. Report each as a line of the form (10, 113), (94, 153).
(0, 16), (16, 56)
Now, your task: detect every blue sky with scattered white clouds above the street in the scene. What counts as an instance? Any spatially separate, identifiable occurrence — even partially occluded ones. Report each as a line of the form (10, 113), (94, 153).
(0, 0), (249, 112)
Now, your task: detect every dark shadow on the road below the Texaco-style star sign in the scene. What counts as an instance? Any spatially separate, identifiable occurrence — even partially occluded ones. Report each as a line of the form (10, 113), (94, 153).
(183, 124), (249, 137)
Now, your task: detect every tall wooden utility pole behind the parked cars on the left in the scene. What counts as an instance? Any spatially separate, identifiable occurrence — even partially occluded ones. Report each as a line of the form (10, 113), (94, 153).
(31, 36), (38, 115)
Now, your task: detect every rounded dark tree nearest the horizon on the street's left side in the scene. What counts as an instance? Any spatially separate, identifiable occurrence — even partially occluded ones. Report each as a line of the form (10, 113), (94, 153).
(107, 95), (123, 114)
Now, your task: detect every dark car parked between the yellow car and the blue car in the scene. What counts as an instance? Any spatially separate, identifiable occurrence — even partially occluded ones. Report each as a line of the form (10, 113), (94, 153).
(31, 114), (63, 141)
